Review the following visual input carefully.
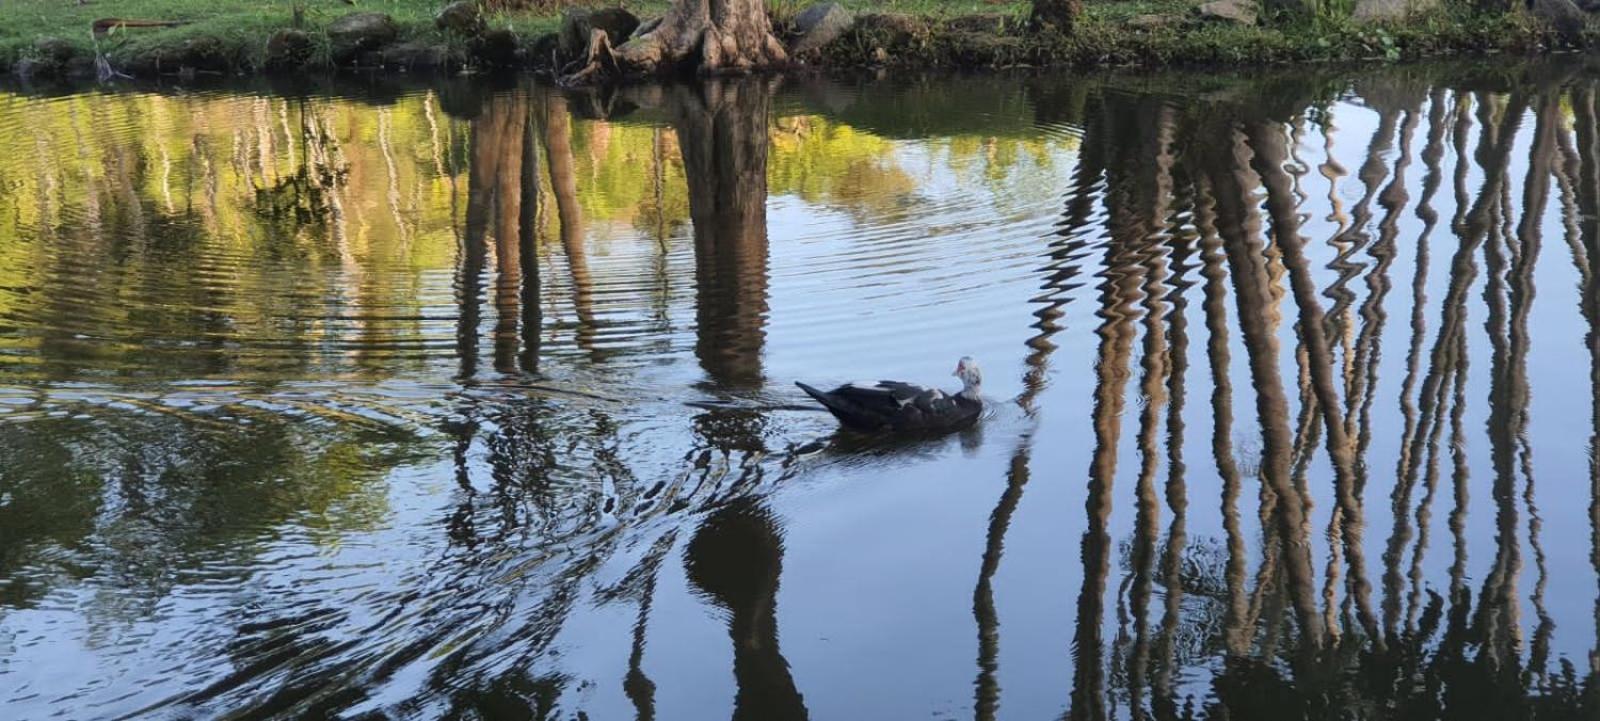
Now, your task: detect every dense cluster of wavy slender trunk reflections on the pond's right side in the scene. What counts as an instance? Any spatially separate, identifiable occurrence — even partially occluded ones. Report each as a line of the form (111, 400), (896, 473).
(1067, 63), (1600, 718)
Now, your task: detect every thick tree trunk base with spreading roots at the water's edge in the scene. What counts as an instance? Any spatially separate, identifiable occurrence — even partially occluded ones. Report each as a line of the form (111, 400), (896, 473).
(563, 0), (784, 85)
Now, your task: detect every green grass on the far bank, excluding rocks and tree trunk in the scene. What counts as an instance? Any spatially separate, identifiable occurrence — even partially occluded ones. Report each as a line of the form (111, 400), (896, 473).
(0, 0), (1595, 75)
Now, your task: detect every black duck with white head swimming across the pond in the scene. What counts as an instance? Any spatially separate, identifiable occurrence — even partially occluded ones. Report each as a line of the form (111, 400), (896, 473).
(795, 357), (984, 433)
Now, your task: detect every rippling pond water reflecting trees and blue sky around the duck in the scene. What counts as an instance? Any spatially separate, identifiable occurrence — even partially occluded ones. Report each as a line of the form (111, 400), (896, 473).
(0, 61), (1600, 719)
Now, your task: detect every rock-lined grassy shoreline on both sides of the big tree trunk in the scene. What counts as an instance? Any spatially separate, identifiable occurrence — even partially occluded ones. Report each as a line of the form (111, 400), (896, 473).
(0, 2), (1600, 82)
